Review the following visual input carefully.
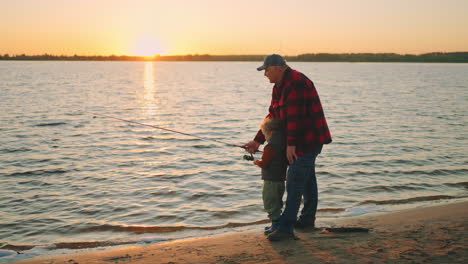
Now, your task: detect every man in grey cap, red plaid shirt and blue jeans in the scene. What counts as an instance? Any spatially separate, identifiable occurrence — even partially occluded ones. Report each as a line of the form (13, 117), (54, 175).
(244, 54), (332, 241)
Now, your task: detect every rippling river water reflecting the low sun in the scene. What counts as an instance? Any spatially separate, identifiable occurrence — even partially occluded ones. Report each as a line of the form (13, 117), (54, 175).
(0, 61), (468, 258)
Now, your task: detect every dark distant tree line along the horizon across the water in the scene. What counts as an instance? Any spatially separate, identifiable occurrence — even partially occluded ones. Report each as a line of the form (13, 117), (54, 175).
(0, 52), (468, 63)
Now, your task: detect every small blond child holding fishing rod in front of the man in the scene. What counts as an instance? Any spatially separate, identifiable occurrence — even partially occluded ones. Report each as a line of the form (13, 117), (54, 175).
(254, 118), (288, 235)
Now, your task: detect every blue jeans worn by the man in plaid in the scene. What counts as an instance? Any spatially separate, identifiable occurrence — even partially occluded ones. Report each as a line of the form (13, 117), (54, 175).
(277, 145), (322, 233)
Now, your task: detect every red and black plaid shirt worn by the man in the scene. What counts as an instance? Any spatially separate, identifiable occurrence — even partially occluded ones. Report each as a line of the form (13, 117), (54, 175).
(254, 68), (332, 156)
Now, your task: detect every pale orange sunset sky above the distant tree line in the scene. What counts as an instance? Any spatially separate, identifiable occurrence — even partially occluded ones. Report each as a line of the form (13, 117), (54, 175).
(0, 0), (468, 56)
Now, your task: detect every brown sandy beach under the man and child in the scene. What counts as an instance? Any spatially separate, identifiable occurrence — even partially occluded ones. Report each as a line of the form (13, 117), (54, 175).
(10, 202), (468, 264)
